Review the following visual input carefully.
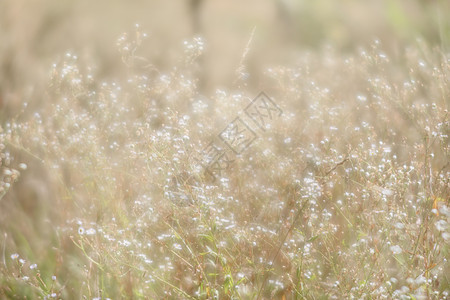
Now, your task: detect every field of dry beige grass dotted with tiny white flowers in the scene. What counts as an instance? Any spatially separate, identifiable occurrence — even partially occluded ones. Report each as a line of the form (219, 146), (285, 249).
(0, 1), (450, 299)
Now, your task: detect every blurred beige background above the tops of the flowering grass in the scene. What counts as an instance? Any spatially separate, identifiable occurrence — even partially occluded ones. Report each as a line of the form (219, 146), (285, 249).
(0, 0), (450, 117)
